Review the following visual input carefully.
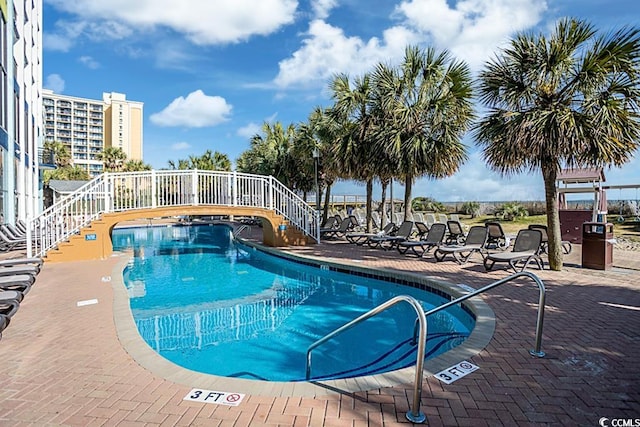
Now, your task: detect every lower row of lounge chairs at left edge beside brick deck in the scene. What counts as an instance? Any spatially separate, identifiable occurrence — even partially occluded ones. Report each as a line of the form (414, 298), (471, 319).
(0, 258), (43, 339)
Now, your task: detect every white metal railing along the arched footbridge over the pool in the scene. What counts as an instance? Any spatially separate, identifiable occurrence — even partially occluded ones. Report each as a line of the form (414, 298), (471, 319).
(27, 169), (320, 256)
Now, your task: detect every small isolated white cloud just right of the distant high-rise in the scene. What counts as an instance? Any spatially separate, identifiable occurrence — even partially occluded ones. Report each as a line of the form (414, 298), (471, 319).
(150, 90), (232, 127)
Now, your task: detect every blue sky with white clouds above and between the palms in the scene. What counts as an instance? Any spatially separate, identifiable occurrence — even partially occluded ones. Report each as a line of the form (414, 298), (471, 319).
(43, 0), (640, 202)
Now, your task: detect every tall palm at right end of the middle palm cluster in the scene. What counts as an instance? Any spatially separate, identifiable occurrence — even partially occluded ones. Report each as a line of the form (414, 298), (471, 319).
(373, 46), (474, 220)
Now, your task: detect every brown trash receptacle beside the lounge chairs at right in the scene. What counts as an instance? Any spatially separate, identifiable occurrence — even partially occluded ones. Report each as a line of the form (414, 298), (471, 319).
(582, 222), (614, 270)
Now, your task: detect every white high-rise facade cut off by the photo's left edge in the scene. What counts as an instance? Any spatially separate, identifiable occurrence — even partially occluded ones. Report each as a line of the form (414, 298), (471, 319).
(0, 0), (43, 223)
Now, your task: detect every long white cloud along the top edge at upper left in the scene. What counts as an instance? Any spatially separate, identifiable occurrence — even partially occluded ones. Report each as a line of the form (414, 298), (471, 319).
(49, 0), (298, 45)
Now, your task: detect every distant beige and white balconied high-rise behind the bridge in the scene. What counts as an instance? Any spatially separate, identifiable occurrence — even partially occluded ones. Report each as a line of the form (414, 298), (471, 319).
(43, 89), (143, 176)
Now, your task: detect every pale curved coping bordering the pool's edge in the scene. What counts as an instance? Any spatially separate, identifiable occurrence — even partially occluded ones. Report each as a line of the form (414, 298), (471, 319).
(111, 239), (495, 397)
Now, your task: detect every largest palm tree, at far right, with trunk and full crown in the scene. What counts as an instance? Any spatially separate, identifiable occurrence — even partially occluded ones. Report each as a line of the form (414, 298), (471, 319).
(475, 19), (640, 270)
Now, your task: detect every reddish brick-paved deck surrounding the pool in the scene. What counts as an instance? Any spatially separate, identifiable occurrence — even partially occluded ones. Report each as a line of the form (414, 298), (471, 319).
(0, 234), (640, 427)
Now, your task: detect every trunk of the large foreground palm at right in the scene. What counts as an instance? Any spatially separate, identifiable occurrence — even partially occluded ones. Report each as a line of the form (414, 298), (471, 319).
(541, 163), (562, 271)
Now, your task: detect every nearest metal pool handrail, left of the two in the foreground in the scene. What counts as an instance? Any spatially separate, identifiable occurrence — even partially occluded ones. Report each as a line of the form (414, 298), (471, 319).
(306, 295), (427, 423)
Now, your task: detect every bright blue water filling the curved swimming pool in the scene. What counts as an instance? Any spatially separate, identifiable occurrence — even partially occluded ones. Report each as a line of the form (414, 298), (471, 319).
(112, 225), (474, 381)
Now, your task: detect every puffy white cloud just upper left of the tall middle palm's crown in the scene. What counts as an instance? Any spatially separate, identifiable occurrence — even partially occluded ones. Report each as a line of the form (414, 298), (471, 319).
(274, 20), (417, 88)
